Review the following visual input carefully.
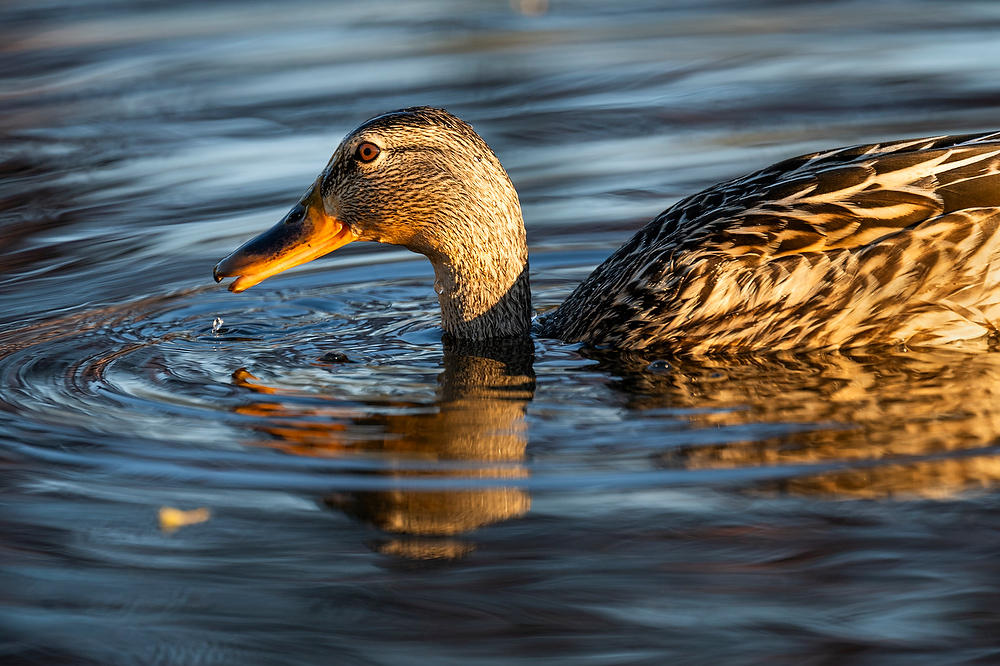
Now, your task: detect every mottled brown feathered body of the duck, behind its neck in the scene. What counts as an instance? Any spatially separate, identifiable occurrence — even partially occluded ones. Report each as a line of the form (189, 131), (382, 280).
(541, 132), (1000, 351)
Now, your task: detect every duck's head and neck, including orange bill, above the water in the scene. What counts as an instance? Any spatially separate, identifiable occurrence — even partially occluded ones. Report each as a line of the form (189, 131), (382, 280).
(214, 107), (530, 339)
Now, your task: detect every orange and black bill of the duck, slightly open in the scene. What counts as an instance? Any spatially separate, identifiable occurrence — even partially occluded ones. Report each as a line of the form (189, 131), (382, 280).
(213, 182), (356, 293)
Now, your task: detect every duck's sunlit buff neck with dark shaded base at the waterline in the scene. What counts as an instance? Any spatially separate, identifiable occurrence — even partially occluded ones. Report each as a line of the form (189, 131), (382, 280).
(430, 209), (531, 340)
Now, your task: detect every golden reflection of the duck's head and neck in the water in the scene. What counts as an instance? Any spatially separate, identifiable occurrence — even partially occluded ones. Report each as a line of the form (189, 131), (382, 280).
(233, 338), (535, 559)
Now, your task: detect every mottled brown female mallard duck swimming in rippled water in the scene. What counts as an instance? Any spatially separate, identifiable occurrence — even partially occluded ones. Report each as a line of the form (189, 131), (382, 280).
(215, 107), (1000, 352)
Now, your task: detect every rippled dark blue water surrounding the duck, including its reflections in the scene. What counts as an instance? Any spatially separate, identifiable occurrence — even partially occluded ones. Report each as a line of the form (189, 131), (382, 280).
(0, 0), (1000, 664)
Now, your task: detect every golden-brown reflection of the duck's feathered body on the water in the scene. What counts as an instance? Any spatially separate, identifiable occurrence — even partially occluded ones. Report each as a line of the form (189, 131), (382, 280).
(601, 350), (1000, 498)
